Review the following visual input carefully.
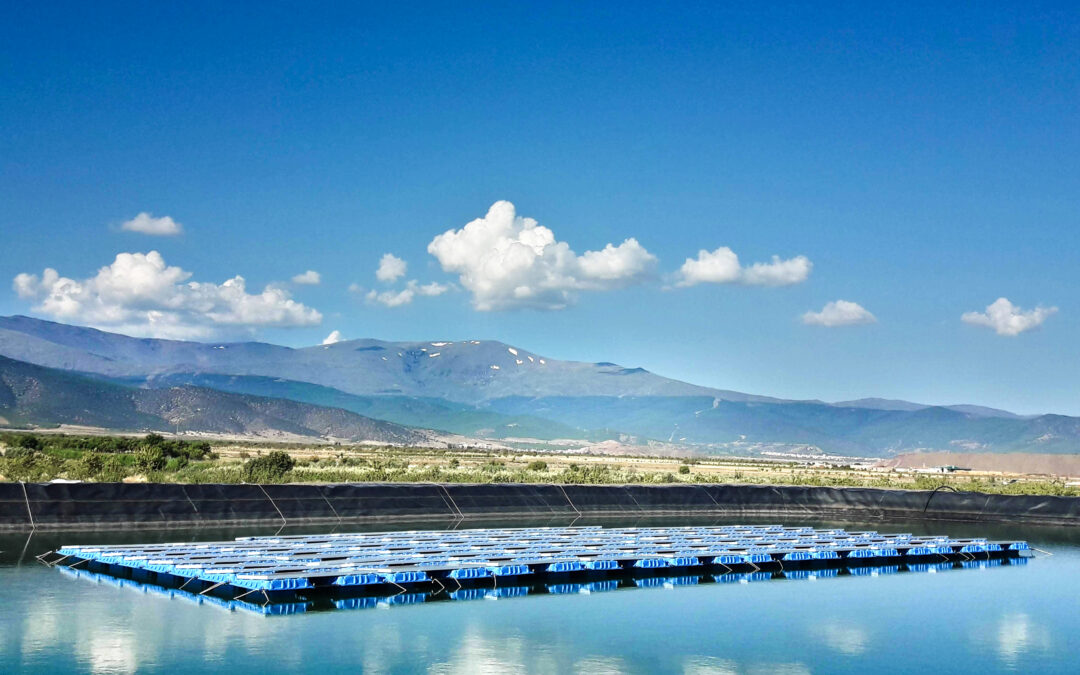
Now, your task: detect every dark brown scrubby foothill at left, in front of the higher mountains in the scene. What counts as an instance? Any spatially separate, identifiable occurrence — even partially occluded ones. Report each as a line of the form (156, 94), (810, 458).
(0, 356), (435, 444)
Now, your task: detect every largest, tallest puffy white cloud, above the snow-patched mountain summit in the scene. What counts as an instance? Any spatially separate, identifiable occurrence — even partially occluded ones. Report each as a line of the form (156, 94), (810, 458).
(428, 201), (657, 311)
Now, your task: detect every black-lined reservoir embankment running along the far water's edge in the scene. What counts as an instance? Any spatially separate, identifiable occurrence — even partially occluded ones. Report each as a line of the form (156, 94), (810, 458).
(0, 483), (1080, 531)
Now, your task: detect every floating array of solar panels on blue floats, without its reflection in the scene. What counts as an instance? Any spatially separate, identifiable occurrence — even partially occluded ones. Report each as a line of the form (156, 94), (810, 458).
(57, 525), (1027, 591)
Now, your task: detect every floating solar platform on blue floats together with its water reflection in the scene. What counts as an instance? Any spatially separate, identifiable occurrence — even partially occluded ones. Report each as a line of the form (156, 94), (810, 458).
(46, 525), (1031, 613)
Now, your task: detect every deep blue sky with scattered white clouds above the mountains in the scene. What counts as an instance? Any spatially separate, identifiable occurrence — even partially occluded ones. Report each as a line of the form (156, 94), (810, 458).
(0, 2), (1080, 415)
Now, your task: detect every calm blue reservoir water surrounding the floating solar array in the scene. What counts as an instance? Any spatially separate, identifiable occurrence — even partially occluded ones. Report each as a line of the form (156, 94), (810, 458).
(0, 521), (1080, 675)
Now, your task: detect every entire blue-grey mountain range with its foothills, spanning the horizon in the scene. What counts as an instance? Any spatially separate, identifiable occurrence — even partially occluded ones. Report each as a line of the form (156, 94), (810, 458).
(0, 316), (1080, 457)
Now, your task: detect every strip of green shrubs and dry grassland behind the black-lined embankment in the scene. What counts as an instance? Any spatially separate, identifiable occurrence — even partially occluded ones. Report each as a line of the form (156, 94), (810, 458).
(0, 433), (1080, 497)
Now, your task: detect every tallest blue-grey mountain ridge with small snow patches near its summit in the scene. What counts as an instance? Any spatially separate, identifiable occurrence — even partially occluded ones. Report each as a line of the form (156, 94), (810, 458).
(0, 316), (779, 404)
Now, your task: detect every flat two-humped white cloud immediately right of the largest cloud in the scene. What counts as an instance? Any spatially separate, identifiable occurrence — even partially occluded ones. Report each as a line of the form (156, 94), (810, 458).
(675, 246), (813, 286)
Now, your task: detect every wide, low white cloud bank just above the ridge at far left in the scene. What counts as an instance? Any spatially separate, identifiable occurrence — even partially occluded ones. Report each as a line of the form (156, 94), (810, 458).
(14, 251), (323, 338)
